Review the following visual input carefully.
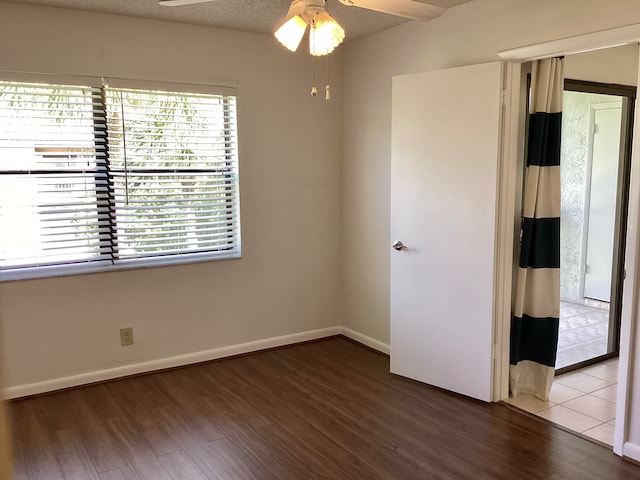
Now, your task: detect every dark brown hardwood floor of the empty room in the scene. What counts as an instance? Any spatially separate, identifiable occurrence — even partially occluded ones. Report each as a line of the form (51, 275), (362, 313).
(6, 338), (640, 480)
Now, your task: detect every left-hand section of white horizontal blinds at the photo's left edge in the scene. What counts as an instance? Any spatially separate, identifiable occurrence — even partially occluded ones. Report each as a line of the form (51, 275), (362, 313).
(0, 83), (109, 269)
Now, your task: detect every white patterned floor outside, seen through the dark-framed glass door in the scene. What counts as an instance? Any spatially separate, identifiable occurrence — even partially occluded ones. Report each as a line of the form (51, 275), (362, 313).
(556, 302), (609, 368)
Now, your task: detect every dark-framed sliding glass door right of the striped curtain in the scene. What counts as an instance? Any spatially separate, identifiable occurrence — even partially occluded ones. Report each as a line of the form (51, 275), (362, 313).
(556, 80), (635, 374)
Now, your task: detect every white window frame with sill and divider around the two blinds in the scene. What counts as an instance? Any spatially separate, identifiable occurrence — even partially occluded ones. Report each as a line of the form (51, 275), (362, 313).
(0, 70), (242, 283)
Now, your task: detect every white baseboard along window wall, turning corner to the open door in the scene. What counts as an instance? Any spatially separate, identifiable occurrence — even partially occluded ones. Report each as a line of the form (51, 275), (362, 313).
(3, 327), (342, 399)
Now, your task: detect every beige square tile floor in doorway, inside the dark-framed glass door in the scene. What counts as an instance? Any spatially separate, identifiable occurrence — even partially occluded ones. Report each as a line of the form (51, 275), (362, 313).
(507, 358), (618, 446)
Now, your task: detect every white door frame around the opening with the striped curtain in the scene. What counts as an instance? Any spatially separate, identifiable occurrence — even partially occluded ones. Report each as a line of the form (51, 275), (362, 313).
(493, 24), (640, 458)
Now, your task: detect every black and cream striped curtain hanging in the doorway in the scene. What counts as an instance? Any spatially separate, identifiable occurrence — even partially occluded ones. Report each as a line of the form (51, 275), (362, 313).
(509, 58), (564, 400)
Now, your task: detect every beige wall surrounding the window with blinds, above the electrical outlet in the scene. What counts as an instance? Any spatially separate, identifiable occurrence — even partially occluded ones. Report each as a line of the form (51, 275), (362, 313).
(0, 3), (341, 387)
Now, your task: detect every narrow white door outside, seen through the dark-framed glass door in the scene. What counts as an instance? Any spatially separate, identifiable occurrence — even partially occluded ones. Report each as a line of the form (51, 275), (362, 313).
(584, 101), (622, 302)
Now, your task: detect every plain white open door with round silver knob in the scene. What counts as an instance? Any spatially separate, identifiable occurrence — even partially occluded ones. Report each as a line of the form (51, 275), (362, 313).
(390, 63), (502, 401)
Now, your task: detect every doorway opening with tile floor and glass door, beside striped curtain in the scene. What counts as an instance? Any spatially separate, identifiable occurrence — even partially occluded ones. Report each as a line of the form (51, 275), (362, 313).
(506, 45), (638, 446)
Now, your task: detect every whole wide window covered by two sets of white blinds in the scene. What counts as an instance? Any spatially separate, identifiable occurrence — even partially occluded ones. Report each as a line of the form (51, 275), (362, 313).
(0, 82), (240, 279)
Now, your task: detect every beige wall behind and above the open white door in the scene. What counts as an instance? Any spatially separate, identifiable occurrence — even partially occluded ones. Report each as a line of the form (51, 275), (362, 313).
(341, 0), (640, 458)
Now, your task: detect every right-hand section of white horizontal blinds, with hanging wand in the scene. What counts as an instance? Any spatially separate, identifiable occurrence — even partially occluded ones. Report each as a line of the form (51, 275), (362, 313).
(106, 89), (238, 259)
